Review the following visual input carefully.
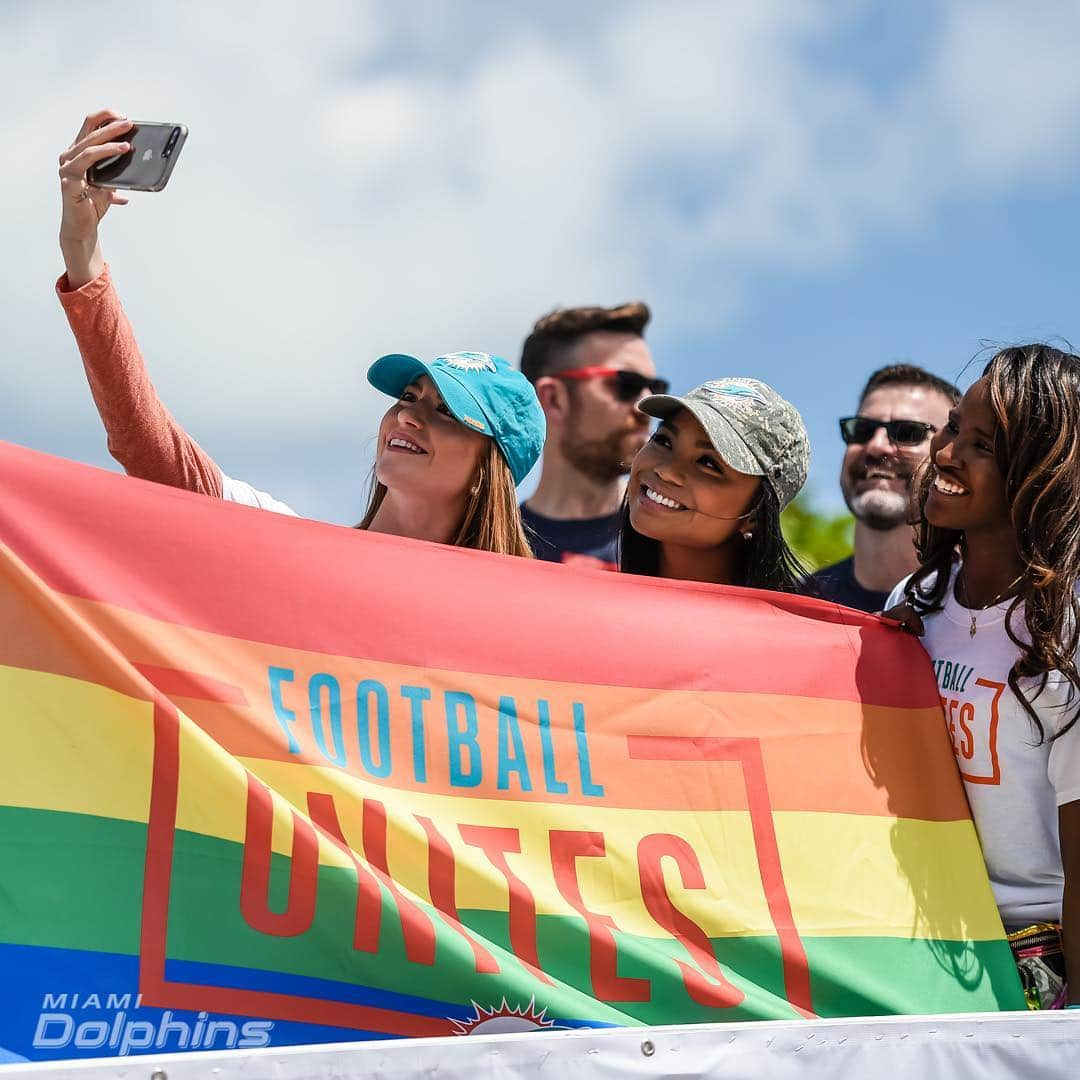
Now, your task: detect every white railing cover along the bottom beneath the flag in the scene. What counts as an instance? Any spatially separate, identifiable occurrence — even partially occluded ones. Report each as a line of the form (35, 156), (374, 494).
(0, 1012), (1080, 1080)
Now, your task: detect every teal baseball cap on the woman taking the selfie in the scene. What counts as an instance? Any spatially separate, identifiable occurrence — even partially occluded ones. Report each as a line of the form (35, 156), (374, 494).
(367, 352), (548, 484)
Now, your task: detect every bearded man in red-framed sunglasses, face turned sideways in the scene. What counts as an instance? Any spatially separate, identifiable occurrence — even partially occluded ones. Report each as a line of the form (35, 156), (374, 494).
(522, 301), (667, 569)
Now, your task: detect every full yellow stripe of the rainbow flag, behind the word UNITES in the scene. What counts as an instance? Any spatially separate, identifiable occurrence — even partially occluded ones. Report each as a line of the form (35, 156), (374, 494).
(0, 666), (1000, 941)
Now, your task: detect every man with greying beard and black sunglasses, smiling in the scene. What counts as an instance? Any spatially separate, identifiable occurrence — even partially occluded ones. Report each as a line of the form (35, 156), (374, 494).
(811, 364), (960, 611)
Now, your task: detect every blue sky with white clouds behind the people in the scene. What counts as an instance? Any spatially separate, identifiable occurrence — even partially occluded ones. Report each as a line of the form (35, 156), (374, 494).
(0, 0), (1080, 523)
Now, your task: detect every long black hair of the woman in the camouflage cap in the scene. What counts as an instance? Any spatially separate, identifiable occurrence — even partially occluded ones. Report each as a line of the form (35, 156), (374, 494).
(619, 481), (808, 593)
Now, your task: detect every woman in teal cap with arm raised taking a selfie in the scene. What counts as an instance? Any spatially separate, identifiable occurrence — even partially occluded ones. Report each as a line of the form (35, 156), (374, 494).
(56, 110), (544, 557)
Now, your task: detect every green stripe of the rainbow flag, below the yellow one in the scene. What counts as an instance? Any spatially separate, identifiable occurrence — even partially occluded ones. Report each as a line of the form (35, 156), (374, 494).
(0, 808), (1024, 1024)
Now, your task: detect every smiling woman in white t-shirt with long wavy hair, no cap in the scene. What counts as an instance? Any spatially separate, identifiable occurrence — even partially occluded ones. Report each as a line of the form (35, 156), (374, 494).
(889, 345), (1080, 1008)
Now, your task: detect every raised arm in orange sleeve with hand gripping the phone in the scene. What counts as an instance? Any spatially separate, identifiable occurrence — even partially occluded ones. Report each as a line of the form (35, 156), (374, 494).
(56, 110), (222, 498)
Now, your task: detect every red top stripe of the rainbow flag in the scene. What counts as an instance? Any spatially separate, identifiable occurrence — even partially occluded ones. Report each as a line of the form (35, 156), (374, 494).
(0, 445), (937, 707)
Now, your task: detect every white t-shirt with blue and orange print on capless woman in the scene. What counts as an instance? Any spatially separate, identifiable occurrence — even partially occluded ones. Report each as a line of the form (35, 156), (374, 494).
(886, 564), (1080, 929)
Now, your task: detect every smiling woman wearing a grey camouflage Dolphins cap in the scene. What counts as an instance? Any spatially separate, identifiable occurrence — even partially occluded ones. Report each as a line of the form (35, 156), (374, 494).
(620, 378), (810, 592)
